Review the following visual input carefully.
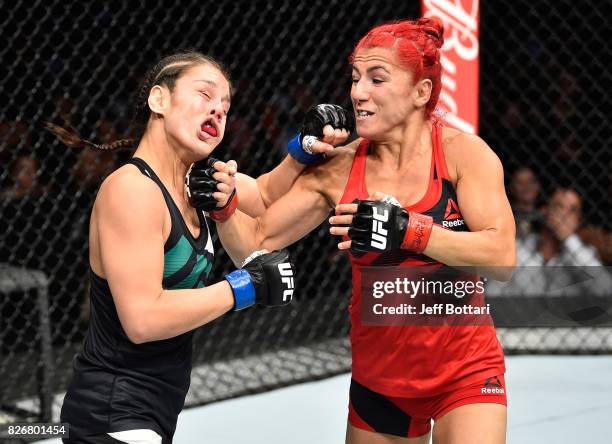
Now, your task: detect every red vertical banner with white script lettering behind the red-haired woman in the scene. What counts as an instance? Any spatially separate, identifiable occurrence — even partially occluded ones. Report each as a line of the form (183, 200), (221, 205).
(421, 0), (480, 134)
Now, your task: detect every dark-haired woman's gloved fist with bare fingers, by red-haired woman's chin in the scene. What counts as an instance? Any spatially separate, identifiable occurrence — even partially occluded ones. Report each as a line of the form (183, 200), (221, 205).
(287, 104), (355, 165)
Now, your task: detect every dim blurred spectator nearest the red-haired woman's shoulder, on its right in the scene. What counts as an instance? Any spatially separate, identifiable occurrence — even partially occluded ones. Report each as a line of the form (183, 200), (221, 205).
(509, 167), (540, 239)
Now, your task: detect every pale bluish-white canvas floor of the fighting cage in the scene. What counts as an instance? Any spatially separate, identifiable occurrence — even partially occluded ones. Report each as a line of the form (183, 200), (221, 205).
(34, 356), (612, 444)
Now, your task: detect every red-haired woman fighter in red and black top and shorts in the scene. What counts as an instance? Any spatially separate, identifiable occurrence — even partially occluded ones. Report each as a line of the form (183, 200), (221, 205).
(197, 18), (516, 444)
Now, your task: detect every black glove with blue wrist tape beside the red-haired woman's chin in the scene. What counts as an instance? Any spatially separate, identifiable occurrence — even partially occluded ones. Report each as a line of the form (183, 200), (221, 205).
(287, 104), (355, 165)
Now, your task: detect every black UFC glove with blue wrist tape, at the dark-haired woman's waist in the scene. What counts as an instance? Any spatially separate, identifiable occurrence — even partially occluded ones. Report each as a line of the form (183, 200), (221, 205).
(225, 250), (295, 310)
